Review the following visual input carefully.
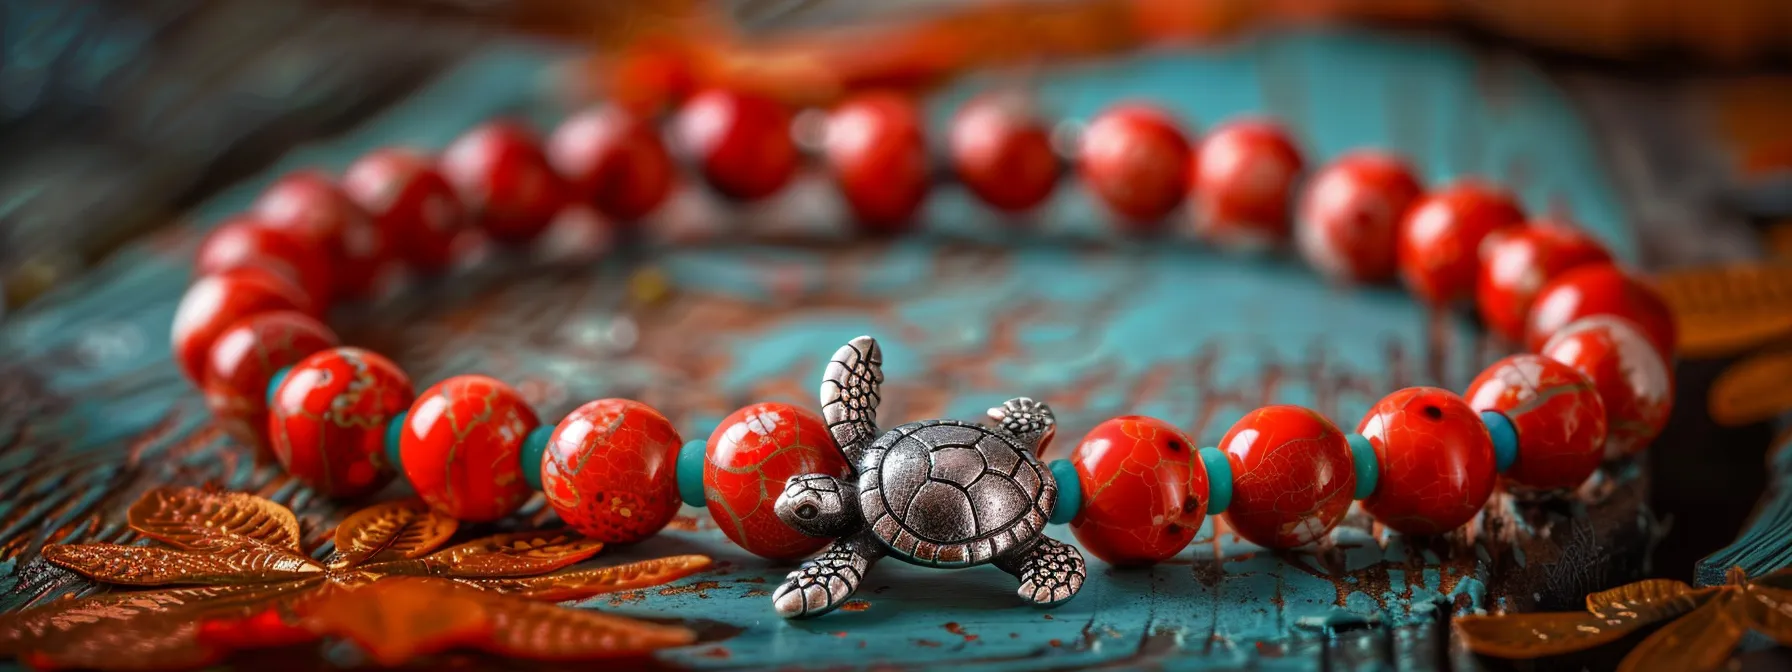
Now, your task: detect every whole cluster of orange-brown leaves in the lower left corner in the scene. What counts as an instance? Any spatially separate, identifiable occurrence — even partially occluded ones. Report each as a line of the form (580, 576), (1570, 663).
(0, 487), (710, 670)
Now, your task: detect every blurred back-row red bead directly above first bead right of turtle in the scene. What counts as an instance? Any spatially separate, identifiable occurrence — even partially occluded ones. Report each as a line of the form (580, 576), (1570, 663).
(1077, 104), (1193, 233)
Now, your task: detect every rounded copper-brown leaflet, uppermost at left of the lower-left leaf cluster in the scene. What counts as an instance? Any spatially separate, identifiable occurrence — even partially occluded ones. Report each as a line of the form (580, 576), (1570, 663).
(127, 487), (303, 554)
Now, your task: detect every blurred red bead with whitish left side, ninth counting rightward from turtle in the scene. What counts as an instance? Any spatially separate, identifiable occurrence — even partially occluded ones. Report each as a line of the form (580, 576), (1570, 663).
(1294, 151), (1421, 283)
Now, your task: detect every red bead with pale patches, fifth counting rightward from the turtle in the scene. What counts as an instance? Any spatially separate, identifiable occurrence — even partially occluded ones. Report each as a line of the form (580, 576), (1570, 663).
(1539, 315), (1674, 457)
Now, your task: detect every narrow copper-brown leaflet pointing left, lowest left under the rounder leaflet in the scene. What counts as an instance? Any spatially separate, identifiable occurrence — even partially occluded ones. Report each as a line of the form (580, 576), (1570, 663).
(43, 543), (324, 586)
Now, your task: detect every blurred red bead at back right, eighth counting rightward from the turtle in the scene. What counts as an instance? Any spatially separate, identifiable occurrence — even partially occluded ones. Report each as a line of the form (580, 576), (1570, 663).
(1394, 179), (1525, 306)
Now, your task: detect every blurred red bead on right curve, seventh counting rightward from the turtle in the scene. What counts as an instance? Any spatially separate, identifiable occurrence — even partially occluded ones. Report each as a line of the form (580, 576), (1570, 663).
(1475, 224), (1611, 342)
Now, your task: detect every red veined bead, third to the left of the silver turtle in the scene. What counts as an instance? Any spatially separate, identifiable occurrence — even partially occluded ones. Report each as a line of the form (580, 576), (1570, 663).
(398, 376), (541, 521)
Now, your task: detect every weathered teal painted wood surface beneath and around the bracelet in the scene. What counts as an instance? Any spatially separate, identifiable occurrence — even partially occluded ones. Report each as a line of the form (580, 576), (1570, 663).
(0, 28), (1652, 670)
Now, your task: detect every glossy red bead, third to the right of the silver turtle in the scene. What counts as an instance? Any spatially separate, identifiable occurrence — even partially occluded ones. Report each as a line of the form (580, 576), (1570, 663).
(1357, 387), (1498, 534)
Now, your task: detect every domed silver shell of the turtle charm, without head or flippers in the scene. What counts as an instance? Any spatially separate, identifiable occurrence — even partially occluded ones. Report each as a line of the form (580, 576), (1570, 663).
(858, 419), (1057, 566)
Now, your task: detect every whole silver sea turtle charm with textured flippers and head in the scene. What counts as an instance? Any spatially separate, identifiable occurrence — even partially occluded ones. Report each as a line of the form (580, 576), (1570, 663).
(772, 337), (1088, 618)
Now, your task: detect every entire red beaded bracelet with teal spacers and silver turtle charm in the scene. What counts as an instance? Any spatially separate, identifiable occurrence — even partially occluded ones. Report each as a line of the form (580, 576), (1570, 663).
(174, 90), (1674, 616)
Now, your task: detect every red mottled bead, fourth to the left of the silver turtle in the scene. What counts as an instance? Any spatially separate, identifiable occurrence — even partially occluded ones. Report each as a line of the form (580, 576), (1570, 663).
(267, 348), (412, 496)
